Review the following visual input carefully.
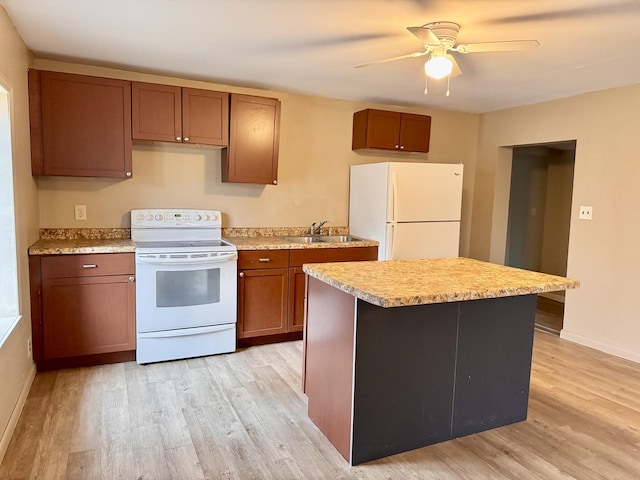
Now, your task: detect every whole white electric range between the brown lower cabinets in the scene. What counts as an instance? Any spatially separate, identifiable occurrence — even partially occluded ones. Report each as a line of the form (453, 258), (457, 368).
(131, 209), (238, 363)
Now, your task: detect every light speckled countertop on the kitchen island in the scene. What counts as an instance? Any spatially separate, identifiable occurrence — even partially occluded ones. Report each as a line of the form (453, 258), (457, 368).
(303, 257), (580, 308)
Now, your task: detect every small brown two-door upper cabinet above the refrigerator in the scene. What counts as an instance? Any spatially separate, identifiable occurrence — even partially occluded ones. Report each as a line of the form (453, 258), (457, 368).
(351, 108), (431, 153)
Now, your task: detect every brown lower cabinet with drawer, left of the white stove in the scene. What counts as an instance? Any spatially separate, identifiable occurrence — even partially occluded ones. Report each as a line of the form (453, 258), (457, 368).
(29, 253), (136, 370)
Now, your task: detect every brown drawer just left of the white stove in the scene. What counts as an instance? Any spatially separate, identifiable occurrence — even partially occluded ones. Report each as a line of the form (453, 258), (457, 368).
(42, 253), (135, 279)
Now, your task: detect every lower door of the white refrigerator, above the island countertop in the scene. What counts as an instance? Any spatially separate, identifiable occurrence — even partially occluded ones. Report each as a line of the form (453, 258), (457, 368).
(378, 222), (460, 260)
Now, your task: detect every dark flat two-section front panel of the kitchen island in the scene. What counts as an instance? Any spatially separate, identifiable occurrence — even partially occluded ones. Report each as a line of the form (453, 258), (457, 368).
(351, 295), (536, 465)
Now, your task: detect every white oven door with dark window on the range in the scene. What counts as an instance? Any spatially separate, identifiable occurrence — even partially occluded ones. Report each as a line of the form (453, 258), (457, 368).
(136, 252), (238, 333)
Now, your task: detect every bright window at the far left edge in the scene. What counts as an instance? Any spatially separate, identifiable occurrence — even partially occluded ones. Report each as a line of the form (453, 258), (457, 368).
(0, 86), (19, 345)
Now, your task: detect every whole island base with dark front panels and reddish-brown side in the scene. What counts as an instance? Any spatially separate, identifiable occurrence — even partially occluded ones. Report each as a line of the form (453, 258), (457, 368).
(303, 278), (536, 465)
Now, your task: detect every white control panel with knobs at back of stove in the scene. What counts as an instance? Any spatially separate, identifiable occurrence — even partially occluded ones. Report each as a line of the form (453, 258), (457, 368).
(131, 208), (222, 228)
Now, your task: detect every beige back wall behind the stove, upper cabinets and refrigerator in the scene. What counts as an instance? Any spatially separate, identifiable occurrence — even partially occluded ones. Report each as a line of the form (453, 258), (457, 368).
(35, 60), (479, 254)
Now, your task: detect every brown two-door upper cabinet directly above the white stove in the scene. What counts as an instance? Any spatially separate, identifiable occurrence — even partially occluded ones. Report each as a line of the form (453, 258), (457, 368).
(131, 82), (229, 147)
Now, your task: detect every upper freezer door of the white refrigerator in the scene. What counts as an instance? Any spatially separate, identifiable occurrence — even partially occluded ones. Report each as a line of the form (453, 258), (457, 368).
(387, 163), (463, 222)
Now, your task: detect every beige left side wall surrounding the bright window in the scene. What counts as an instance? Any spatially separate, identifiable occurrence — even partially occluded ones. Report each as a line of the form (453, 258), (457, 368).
(0, 7), (38, 460)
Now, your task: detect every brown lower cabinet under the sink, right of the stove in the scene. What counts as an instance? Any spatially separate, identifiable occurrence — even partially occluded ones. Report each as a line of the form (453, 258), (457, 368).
(237, 247), (378, 347)
